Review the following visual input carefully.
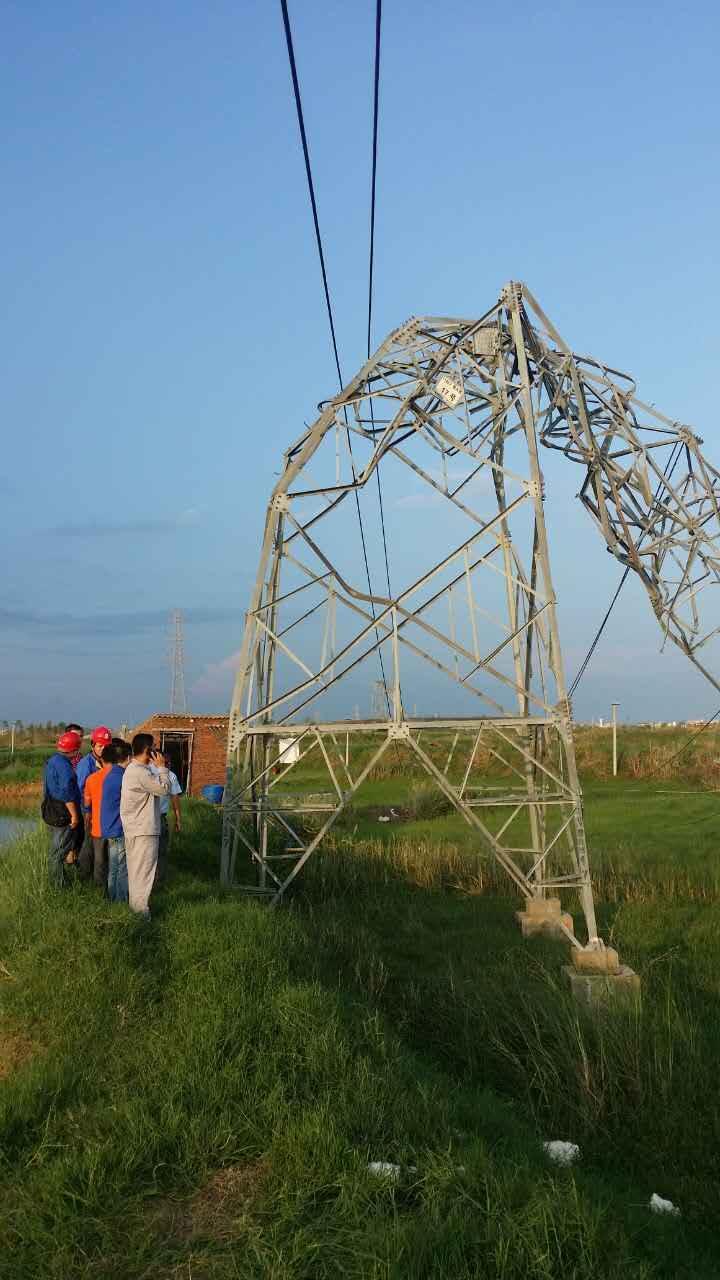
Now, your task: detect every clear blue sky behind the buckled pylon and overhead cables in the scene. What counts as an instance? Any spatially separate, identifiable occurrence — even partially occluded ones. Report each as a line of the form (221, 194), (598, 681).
(0, 0), (720, 723)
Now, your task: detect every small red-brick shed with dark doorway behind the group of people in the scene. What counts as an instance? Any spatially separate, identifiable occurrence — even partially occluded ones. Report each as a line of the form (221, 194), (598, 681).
(129, 712), (229, 796)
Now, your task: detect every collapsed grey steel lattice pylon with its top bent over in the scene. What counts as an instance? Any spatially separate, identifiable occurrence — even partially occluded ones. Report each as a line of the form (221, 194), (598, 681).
(222, 283), (719, 947)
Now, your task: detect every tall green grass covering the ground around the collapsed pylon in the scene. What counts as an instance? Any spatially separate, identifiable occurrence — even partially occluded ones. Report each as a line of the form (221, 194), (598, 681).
(0, 776), (720, 1280)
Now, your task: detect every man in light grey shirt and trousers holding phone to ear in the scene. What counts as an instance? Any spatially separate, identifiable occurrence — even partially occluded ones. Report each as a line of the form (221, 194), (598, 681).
(120, 733), (170, 920)
